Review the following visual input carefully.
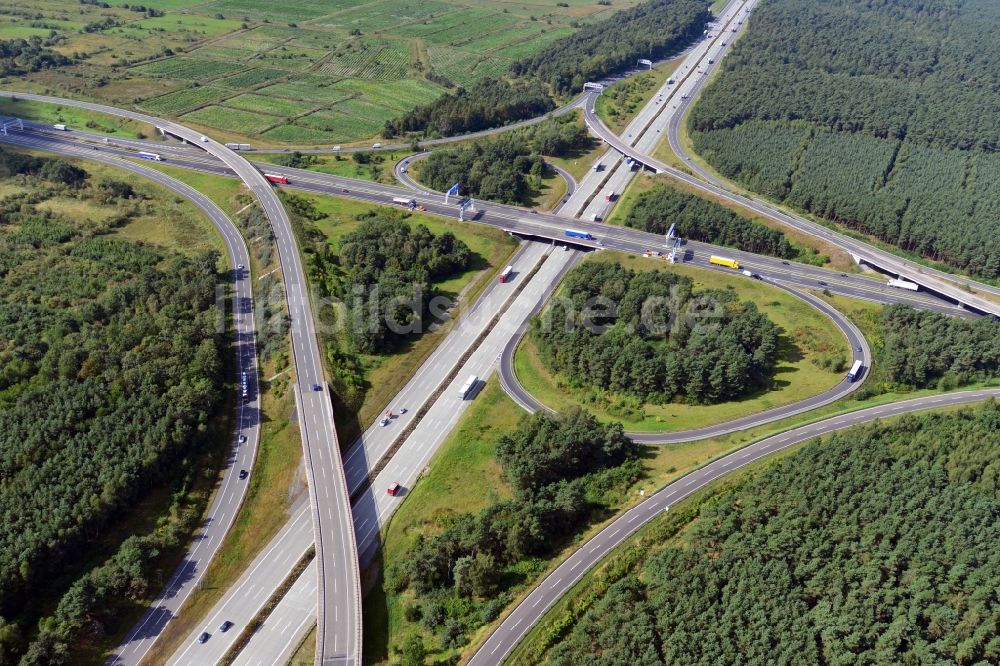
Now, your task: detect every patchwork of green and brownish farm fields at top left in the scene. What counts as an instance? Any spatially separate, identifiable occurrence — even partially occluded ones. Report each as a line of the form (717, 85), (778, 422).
(0, 0), (639, 147)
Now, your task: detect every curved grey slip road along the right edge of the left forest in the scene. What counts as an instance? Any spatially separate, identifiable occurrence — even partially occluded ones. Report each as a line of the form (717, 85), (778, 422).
(0, 137), (260, 664)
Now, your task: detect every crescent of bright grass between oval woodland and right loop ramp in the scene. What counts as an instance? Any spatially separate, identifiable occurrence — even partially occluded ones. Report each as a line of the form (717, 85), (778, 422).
(514, 252), (850, 432)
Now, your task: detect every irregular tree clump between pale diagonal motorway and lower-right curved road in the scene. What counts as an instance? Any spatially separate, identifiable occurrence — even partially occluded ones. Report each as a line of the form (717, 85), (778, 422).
(386, 408), (642, 648)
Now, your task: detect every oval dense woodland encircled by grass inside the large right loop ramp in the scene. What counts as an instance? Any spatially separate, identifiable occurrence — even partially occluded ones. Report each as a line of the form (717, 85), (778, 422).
(531, 261), (778, 403)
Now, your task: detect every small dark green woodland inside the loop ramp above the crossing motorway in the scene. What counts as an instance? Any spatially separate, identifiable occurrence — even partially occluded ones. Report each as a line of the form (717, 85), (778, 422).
(420, 116), (593, 204)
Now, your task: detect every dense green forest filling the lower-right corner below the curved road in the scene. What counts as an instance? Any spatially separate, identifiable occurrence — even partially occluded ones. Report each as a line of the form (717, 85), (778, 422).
(548, 401), (1000, 666)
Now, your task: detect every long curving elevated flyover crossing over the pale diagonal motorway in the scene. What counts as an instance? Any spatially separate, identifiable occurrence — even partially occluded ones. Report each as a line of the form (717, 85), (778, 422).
(0, 91), (361, 664)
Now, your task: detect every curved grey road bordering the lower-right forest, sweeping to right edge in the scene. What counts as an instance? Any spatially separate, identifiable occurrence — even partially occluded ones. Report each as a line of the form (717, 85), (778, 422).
(468, 388), (1000, 666)
